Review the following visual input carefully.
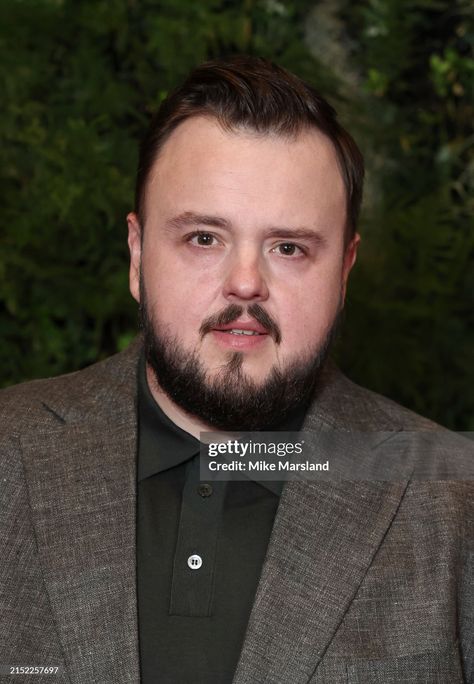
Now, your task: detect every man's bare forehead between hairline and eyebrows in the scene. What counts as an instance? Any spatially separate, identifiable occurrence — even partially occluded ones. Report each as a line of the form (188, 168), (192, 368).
(145, 116), (346, 227)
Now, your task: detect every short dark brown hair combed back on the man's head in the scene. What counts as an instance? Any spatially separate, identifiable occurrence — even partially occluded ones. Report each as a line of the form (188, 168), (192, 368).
(135, 56), (364, 238)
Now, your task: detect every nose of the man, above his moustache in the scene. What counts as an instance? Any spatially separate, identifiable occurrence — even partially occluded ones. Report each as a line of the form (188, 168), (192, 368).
(224, 244), (269, 302)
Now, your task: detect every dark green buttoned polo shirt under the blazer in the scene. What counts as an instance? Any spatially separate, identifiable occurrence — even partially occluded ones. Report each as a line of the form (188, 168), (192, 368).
(137, 359), (304, 684)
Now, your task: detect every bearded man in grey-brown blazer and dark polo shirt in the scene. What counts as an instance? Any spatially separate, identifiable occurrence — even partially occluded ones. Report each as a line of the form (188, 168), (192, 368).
(0, 58), (474, 684)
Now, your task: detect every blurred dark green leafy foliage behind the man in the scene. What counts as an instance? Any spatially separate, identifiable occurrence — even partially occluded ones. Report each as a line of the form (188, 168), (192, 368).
(0, 0), (474, 430)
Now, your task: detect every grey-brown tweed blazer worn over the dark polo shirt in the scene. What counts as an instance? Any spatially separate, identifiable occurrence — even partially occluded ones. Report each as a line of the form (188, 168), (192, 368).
(0, 341), (474, 684)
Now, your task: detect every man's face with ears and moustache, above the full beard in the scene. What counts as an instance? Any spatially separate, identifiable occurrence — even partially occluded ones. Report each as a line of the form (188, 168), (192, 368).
(129, 117), (358, 428)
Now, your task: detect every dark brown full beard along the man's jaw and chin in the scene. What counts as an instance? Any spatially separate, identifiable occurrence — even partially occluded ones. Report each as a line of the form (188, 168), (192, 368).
(140, 276), (341, 431)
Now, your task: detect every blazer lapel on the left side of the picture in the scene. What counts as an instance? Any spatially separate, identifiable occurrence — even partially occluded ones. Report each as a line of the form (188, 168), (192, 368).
(22, 350), (139, 684)
